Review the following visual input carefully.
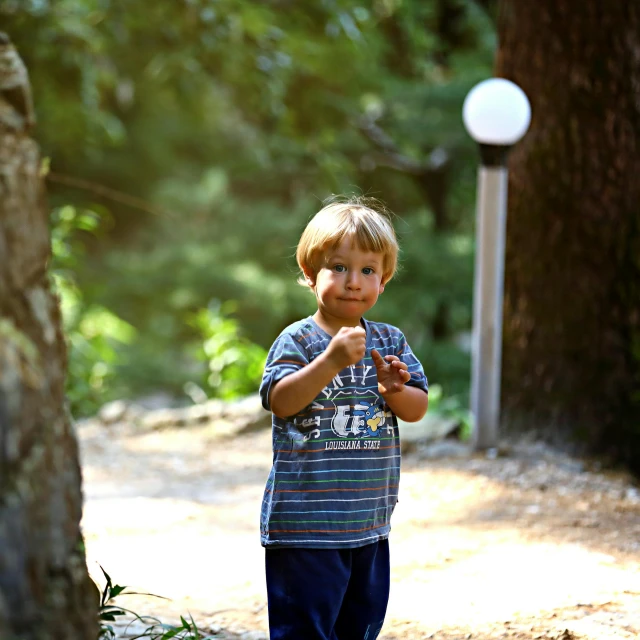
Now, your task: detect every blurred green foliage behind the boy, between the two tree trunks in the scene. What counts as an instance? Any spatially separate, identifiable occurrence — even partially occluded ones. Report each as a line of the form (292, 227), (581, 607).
(0, 0), (496, 416)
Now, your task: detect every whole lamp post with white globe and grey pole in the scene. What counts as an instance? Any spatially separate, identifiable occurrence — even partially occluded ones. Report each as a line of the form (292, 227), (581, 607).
(462, 78), (531, 449)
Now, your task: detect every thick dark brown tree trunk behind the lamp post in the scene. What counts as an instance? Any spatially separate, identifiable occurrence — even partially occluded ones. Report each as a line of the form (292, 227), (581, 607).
(496, 0), (640, 463)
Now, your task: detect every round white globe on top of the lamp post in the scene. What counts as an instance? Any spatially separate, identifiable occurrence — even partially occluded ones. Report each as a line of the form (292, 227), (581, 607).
(462, 78), (531, 145)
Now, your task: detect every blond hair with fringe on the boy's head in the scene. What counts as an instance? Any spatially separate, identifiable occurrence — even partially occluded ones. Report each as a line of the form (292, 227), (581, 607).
(296, 197), (399, 286)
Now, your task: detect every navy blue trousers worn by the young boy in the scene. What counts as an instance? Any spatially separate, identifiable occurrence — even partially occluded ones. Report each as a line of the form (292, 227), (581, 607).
(266, 540), (390, 640)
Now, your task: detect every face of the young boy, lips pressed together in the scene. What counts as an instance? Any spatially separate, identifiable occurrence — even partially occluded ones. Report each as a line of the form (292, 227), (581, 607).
(304, 236), (384, 329)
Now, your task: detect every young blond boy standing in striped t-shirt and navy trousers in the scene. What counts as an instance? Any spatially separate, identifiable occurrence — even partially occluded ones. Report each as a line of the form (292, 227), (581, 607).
(260, 200), (428, 640)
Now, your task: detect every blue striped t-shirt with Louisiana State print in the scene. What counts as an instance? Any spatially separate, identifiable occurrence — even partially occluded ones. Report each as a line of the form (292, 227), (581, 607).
(260, 317), (428, 548)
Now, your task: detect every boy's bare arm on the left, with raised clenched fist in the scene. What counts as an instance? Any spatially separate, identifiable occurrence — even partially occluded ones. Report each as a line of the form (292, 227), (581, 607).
(269, 327), (366, 418)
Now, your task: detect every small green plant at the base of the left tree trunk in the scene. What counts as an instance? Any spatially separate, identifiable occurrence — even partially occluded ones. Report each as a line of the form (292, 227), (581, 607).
(96, 566), (212, 640)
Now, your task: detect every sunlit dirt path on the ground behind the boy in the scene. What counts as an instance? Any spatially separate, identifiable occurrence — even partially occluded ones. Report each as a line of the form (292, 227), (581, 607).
(79, 424), (640, 640)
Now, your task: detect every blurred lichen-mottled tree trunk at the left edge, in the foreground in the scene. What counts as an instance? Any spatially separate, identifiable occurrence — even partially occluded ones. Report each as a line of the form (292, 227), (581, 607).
(0, 34), (98, 640)
